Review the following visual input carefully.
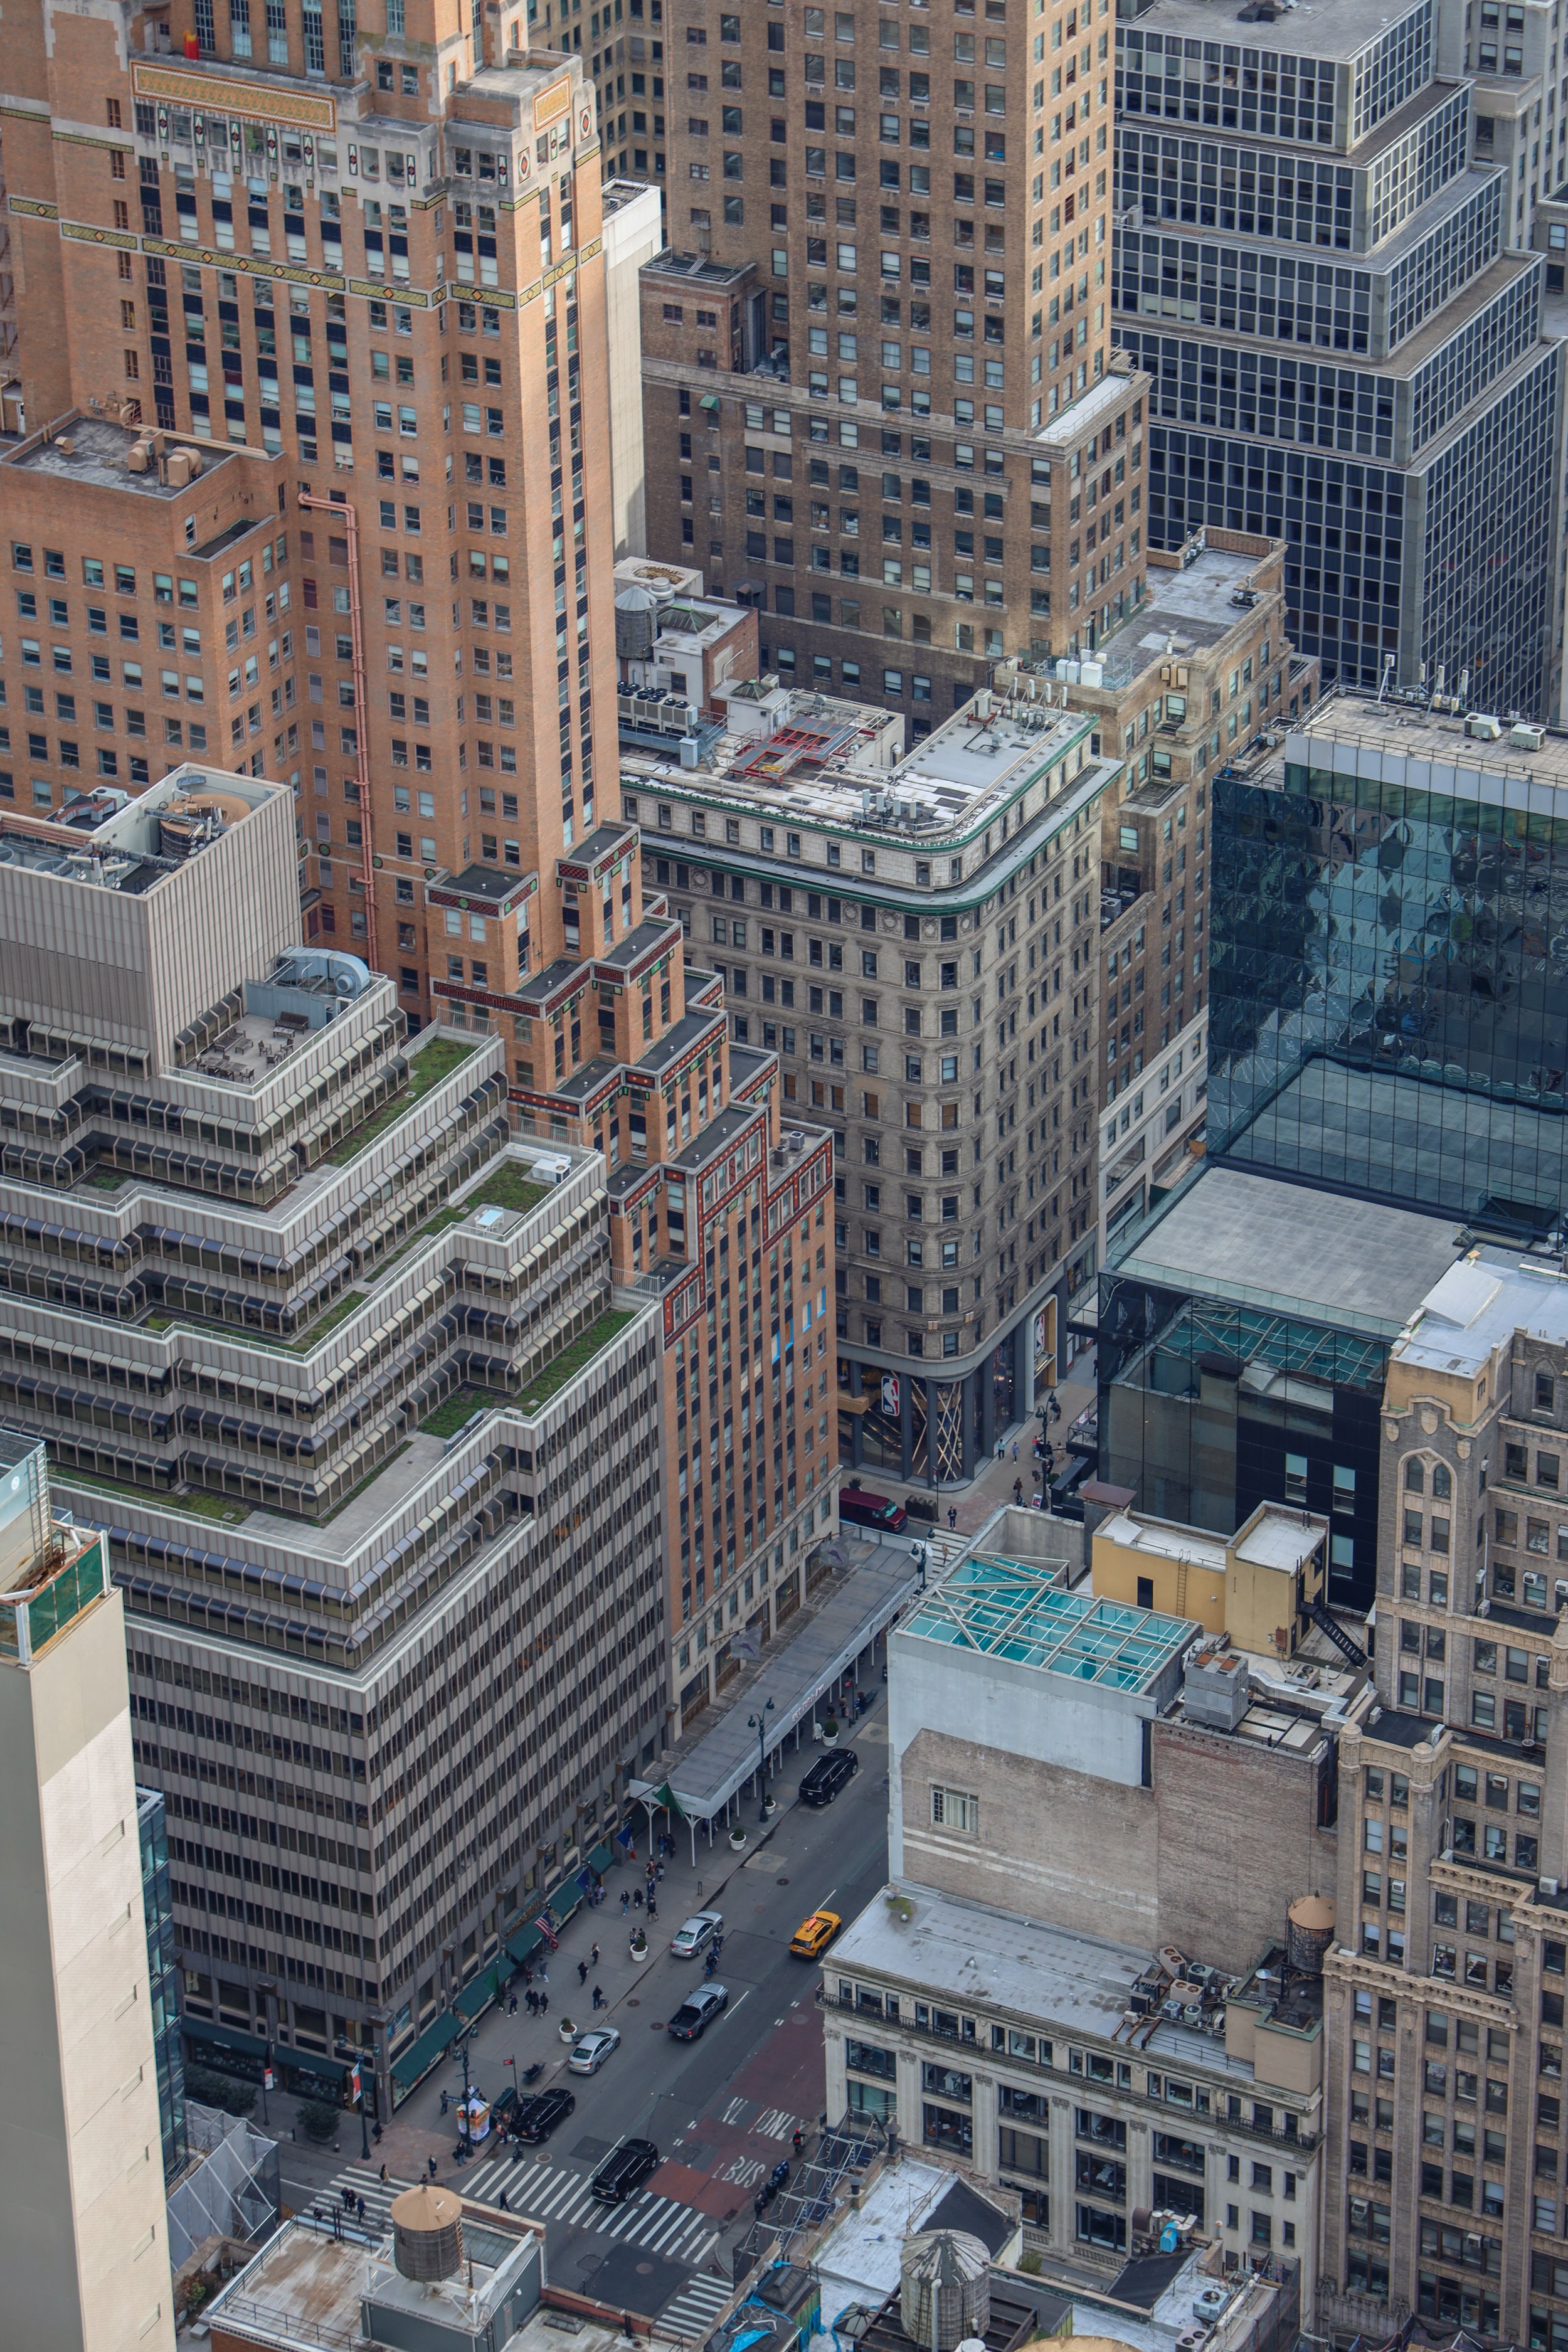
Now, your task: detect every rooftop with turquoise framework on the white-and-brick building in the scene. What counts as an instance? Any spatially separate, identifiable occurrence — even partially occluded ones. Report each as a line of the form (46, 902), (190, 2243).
(903, 1555), (1197, 1691)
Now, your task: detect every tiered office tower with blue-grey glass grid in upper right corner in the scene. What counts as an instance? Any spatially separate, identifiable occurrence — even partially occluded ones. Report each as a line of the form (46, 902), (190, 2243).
(1112, 0), (1564, 718)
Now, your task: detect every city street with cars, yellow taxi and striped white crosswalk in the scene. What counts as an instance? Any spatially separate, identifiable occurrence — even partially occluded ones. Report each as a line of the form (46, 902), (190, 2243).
(282, 1687), (903, 2331)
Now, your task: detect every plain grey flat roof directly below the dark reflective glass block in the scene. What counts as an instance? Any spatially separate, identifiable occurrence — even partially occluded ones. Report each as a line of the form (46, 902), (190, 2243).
(1112, 1162), (1460, 1338)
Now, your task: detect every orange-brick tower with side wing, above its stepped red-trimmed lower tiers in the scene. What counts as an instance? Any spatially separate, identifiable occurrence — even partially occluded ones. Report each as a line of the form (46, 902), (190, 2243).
(4, 0), (637, 1023)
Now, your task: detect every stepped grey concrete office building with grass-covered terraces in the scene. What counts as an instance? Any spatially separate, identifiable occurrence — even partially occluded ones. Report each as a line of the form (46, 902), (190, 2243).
(0, 769), (667, 2112)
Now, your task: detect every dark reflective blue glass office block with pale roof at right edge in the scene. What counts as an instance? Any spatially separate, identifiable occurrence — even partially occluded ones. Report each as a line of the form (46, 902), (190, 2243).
(1209, 696), (1568, 1235)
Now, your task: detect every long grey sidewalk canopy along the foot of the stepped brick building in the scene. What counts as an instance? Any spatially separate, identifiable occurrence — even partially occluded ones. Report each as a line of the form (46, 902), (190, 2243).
(667, 1543), (919, 1821)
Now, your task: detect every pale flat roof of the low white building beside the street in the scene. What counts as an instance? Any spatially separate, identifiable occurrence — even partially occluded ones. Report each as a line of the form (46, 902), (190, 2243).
(841, 1882), (1253, 2082)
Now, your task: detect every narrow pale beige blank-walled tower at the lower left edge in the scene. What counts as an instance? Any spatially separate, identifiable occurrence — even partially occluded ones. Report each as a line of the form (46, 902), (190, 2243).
(0, 1430), (174, 2352)
